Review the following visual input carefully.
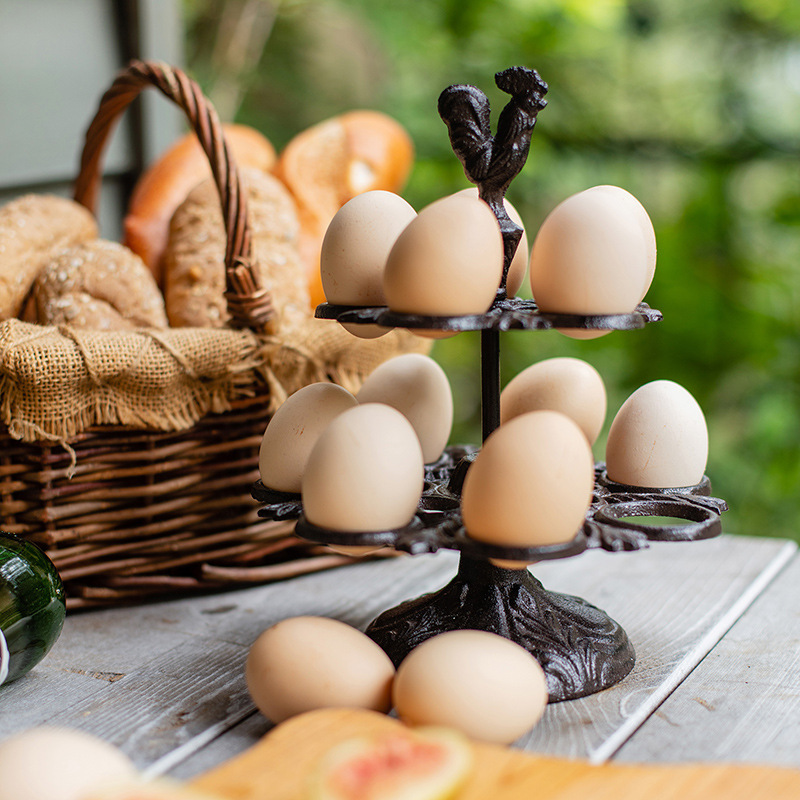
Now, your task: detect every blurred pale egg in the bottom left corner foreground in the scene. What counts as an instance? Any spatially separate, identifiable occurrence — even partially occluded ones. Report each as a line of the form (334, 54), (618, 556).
(0, 726), (138, 800)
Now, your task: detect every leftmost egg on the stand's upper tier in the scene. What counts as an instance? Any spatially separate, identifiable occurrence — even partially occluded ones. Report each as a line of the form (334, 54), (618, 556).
(320, 190), (417, 339)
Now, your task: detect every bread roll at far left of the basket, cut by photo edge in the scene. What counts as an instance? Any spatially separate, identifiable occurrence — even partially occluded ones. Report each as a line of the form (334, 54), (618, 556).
(0, 194), (97, 319)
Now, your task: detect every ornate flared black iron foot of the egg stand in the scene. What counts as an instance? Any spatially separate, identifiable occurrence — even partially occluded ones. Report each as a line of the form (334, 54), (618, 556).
(366, 555), (636, 702)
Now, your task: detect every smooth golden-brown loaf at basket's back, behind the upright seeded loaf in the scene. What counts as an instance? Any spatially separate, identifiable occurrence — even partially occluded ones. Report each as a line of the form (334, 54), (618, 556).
(123, 124), (275, 285)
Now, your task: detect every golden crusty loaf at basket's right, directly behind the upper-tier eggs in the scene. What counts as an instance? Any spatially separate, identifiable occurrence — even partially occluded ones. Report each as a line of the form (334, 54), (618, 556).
(275, 111), (414, 307)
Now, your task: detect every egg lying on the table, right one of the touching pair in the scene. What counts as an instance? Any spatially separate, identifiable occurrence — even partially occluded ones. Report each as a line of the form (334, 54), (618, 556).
(392, 630), (548, 744)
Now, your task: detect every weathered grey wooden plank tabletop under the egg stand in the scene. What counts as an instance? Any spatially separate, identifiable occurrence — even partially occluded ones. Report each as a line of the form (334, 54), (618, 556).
(0, 536), (800, 779)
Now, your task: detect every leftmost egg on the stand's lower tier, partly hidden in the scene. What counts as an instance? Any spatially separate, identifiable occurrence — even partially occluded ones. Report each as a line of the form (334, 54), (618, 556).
(258, 383), (358, 493)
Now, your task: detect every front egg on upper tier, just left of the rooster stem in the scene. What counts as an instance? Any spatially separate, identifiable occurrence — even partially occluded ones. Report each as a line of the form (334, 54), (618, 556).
(383, 195), (503, 316)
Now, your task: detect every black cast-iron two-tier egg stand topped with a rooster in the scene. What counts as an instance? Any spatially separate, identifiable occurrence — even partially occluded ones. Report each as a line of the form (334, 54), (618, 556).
(253, 67), (727, 702)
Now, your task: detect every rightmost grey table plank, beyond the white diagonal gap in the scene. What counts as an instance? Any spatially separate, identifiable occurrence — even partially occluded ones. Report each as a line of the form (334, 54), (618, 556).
(619, 558), (800, 765)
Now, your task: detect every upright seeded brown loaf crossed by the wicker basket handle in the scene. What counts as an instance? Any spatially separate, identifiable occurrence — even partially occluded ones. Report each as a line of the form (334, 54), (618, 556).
(164, 170), (309, 327)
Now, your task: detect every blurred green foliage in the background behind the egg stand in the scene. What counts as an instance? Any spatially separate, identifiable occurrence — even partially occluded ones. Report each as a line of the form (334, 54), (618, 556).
(184, 0), (800, 539)
